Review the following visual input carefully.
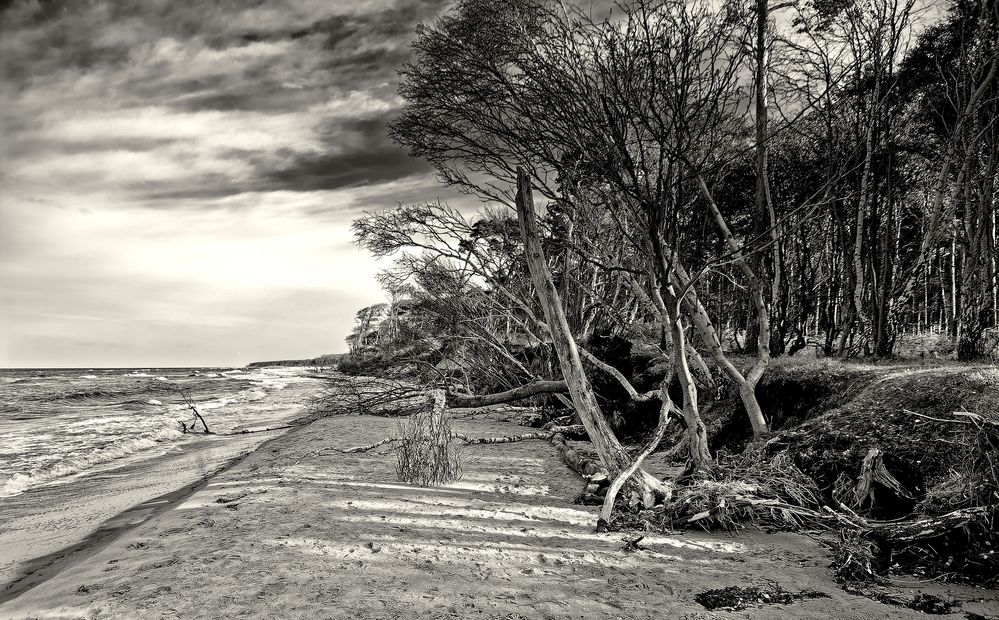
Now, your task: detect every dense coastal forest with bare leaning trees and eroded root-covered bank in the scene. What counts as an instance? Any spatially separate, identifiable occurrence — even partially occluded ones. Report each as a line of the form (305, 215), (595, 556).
(317, 0), (999, 585)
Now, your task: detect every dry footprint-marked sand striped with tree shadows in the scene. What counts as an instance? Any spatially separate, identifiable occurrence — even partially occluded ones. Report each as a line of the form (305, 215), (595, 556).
(0, 416), (999, 620)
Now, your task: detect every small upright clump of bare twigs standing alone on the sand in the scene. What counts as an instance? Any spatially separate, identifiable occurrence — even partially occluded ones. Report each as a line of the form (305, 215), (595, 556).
(395, 390), (461, 487)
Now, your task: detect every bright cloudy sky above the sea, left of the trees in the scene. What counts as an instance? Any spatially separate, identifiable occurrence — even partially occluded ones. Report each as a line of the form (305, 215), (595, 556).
(0, 0), (460, 367)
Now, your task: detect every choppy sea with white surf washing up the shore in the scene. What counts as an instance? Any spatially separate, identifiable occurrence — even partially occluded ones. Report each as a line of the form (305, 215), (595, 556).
(0, 367), (321, 588)
